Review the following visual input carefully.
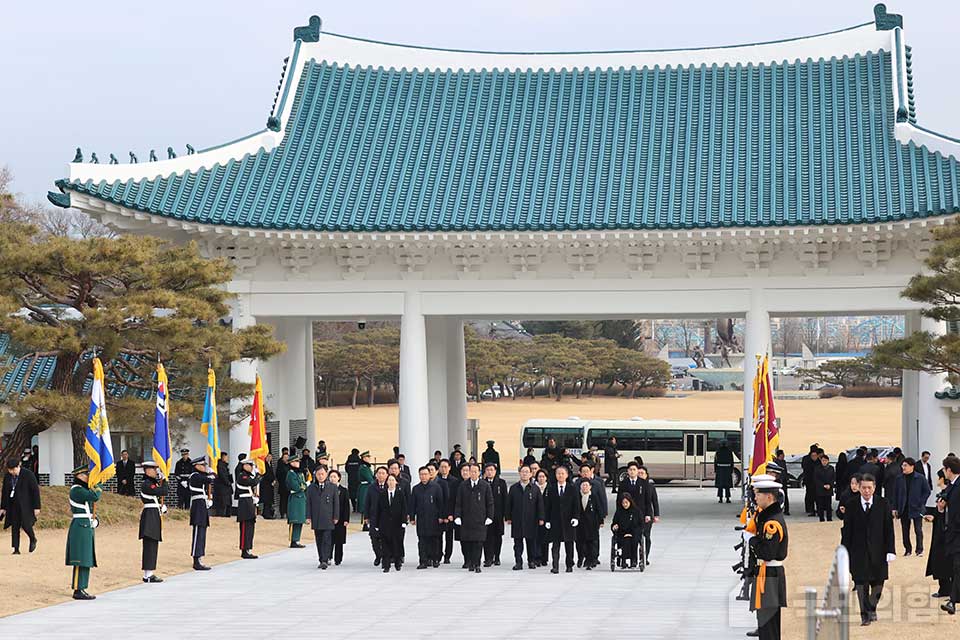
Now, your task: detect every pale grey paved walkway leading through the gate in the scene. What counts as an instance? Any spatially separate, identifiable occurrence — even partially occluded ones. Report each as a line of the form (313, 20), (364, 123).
(0, 488), (752, 640)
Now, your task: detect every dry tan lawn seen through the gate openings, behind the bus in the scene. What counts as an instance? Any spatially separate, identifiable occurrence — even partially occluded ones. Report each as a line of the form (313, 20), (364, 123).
(317, 391), (900, 464)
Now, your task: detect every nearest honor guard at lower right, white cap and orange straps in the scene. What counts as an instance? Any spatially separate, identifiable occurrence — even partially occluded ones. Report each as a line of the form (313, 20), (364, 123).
(748, 479), (787, 640)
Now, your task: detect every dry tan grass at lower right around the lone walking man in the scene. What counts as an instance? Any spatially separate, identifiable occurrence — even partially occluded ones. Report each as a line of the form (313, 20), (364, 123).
(783, 516), (957, 640)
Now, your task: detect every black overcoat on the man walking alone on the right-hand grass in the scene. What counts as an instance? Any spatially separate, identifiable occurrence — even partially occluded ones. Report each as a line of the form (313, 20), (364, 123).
(840, 495), (895, 584)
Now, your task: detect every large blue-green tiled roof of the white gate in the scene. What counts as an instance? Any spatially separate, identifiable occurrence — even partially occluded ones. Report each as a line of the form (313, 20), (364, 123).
(58, 30), (960, 232)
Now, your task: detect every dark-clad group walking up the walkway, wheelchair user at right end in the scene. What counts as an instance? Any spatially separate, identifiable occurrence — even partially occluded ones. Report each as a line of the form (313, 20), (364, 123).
(358, 441), (659, 573)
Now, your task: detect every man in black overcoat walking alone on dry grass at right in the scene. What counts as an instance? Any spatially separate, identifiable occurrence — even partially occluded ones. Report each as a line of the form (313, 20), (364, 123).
(840, 474), (897, 626)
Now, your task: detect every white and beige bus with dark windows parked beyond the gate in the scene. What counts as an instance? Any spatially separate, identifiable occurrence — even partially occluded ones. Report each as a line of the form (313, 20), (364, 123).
(520, 418), (741, 485)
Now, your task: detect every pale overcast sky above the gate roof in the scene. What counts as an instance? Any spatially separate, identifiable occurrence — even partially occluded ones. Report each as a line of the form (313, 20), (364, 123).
(0, 0), (960, 200)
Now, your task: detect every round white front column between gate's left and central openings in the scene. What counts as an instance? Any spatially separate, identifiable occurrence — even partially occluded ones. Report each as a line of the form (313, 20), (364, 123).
(400, 291), (430, 467)
